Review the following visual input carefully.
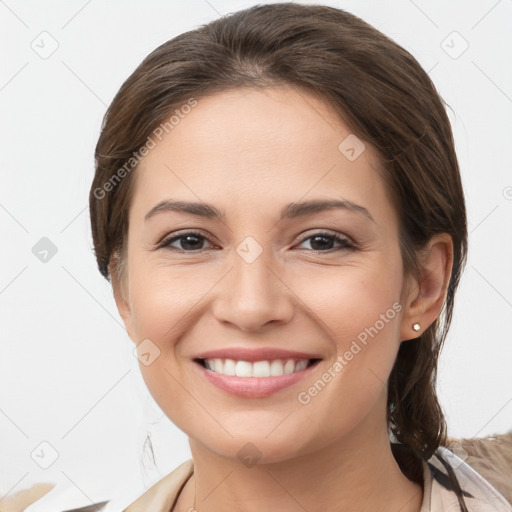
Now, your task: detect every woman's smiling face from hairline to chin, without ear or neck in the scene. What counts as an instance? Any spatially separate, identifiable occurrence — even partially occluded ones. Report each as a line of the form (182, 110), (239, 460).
(114, 87), (420, 462)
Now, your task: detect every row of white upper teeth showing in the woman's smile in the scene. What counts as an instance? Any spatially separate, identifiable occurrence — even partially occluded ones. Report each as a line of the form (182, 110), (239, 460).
(204, 358), (308, 377)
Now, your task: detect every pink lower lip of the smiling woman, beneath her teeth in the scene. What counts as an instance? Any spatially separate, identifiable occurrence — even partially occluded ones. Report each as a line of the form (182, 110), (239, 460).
(194, 361), (320, 398)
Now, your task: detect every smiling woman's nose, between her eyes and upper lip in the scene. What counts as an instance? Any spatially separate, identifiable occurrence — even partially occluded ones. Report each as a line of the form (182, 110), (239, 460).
(212, 244), (294, 332)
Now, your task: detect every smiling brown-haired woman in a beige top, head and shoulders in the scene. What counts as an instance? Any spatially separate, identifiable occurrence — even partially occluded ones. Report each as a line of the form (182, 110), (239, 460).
(90, 3), (512, 512)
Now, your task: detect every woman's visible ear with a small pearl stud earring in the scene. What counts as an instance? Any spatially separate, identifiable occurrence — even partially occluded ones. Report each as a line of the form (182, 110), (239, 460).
(400, 233), (453, 341)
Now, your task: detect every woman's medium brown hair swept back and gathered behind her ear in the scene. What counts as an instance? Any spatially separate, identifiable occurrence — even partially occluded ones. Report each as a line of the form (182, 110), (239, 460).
(90, 2), (467, 476)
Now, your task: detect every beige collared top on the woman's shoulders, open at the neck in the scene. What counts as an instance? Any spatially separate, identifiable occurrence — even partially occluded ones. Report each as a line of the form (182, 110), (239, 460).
(123, 447), (512, 512)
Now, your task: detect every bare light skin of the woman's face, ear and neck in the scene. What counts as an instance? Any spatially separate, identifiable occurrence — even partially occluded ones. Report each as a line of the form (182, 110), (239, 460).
(112, 87), (453, 512)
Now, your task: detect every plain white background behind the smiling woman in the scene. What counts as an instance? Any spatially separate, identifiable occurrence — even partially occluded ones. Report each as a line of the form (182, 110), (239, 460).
(0, 0), (512, 512)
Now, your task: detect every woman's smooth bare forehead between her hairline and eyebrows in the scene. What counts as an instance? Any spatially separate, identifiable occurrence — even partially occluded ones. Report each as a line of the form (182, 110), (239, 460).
(132, 87), (393, 227)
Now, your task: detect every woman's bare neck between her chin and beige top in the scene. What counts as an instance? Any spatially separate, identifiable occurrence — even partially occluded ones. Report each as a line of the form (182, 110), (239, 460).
(175, 420), (423, 512)
